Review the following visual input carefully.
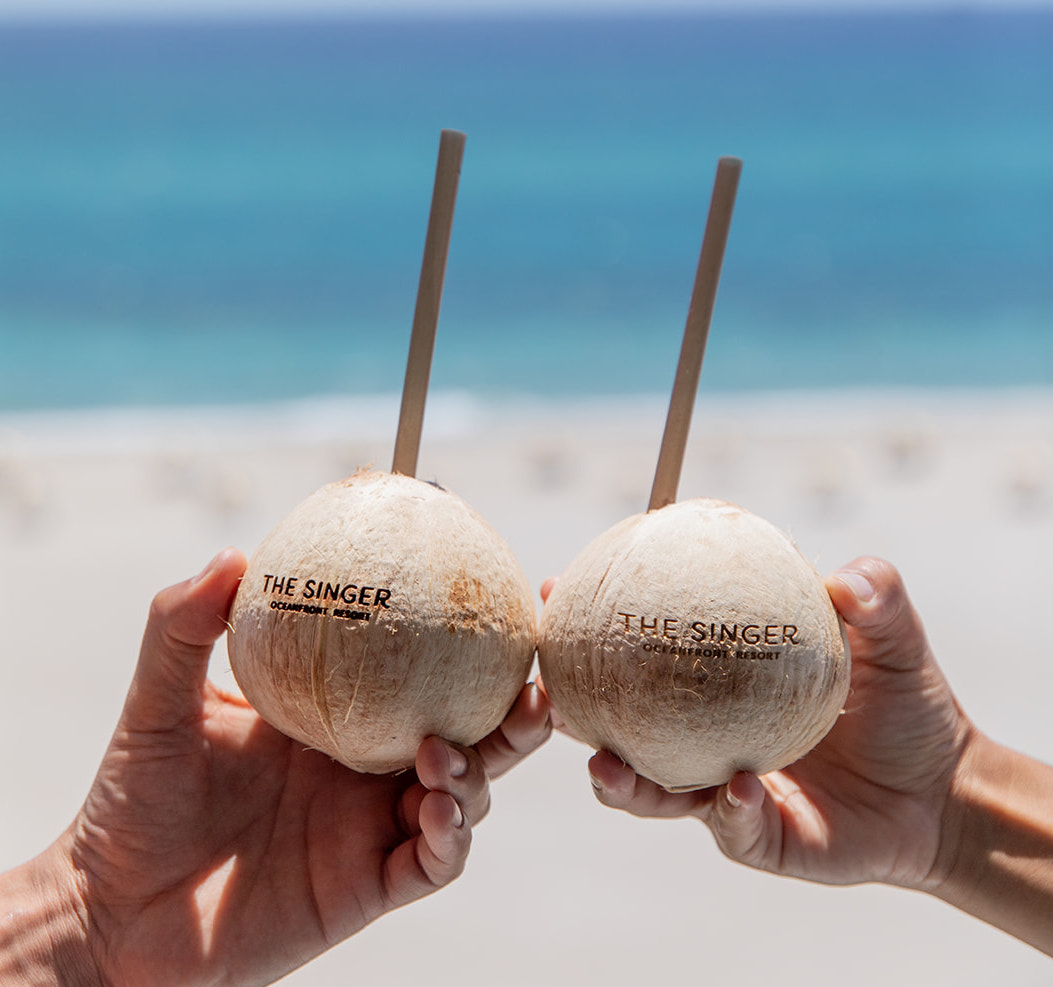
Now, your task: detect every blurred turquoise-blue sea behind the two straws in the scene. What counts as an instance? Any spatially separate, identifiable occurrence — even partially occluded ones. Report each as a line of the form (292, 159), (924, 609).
(0, 13), (1053, 410)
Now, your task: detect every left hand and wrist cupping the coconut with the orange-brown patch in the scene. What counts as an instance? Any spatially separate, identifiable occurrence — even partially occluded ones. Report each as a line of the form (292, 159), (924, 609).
(0, 550), (551, 987)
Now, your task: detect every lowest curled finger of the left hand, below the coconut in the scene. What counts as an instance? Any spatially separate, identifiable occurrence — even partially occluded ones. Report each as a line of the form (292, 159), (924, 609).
(383, 791), (472, 908)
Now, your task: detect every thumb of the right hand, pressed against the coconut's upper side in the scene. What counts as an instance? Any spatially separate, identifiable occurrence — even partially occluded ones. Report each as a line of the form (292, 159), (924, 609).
(827, 557), (929, 670)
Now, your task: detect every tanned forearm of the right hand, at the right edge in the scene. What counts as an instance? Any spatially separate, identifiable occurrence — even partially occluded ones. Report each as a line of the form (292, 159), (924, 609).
(930, 732), (1053, 955)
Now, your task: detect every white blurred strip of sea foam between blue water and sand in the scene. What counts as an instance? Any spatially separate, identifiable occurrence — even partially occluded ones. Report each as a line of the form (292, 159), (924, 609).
(0, 388), (1053, 456)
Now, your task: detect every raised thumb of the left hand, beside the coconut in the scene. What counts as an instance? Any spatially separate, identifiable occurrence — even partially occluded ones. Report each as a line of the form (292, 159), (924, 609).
(124, 548), (245, 730)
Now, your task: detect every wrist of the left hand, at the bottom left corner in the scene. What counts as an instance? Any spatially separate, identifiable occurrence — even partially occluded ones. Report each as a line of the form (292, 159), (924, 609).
(0, 837), (102, 987)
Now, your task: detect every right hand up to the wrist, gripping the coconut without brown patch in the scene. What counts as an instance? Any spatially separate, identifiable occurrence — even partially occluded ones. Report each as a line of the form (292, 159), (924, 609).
(547, 558), (971, 887)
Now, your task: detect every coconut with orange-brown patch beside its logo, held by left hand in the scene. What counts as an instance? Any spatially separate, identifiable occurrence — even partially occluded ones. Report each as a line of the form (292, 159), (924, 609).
(227, 471), (536, 773)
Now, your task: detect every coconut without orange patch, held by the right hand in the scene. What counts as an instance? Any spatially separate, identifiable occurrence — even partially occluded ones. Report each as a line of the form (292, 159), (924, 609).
(538, 498), (850, 791)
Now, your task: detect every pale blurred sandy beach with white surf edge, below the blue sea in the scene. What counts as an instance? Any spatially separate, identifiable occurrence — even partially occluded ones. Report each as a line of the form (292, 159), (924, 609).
(0, 391), (1053, 987)
